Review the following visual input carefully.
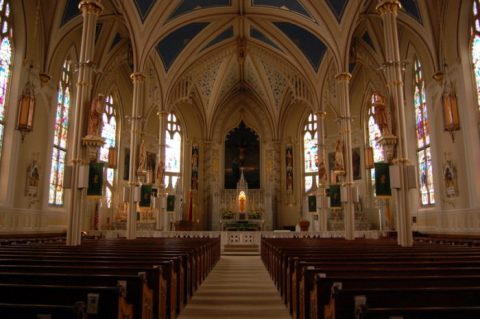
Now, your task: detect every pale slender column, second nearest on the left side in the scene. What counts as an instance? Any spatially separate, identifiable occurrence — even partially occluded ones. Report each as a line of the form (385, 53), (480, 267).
(127, 73), (145, 239)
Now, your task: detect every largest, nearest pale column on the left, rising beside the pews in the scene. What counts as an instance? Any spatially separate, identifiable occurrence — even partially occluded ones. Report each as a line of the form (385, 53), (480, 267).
(67, 0), (103, 246)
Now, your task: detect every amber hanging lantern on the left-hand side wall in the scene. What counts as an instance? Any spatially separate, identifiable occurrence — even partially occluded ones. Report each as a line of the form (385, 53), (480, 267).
(15, 65), (35, 143)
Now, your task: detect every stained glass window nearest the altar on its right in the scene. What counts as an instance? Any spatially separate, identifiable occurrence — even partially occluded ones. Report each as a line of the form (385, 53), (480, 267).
(303, 113), (318, 192)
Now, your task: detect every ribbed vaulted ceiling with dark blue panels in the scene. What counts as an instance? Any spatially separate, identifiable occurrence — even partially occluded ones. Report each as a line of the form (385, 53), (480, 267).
(52, 0), (424, 129)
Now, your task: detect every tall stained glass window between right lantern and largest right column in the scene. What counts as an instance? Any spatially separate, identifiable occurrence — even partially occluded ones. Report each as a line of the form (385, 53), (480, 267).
(414, 59), (435, 206)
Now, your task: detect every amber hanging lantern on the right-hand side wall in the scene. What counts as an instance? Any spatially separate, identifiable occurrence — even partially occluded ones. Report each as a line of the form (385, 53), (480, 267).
(442, 65), (460, 142)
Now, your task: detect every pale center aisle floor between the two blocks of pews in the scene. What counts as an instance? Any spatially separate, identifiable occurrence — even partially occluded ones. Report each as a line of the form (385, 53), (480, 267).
(179, 256), (291, 319)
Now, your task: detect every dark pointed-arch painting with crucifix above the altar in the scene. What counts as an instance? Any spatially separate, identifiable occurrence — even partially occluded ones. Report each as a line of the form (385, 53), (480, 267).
(224, 121), (260, 189)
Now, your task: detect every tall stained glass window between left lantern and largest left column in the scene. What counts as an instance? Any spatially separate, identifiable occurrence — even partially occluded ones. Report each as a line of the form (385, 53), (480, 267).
(48, 60), (71, 206)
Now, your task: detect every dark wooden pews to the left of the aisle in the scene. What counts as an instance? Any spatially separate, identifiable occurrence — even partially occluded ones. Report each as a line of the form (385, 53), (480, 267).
(0, 238), (220, 319)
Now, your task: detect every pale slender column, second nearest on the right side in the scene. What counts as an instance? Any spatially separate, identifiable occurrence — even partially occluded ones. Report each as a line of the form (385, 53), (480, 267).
(335, 73), (355, 240)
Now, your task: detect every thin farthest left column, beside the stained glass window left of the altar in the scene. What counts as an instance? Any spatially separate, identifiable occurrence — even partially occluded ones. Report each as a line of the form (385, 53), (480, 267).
(157, 110), (170, 230)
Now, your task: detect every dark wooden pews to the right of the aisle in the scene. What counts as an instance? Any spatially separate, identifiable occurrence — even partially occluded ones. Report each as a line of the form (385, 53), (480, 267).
(261, 238), (480, 319)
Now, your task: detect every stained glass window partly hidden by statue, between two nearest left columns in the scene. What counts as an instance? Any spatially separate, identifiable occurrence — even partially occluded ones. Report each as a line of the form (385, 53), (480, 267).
(100, 95), (117, 207)
